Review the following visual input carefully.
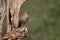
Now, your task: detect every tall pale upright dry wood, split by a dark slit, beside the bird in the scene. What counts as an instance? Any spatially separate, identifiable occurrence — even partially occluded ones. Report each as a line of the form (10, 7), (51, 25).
(7, 0), (26, 32)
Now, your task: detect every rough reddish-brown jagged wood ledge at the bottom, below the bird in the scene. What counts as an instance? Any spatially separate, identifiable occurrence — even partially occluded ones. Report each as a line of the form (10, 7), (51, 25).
(3, 27), (27, 40)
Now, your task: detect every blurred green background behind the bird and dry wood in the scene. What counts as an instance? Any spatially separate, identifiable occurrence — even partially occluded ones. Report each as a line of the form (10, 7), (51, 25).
(3, 0), (60, 40)
